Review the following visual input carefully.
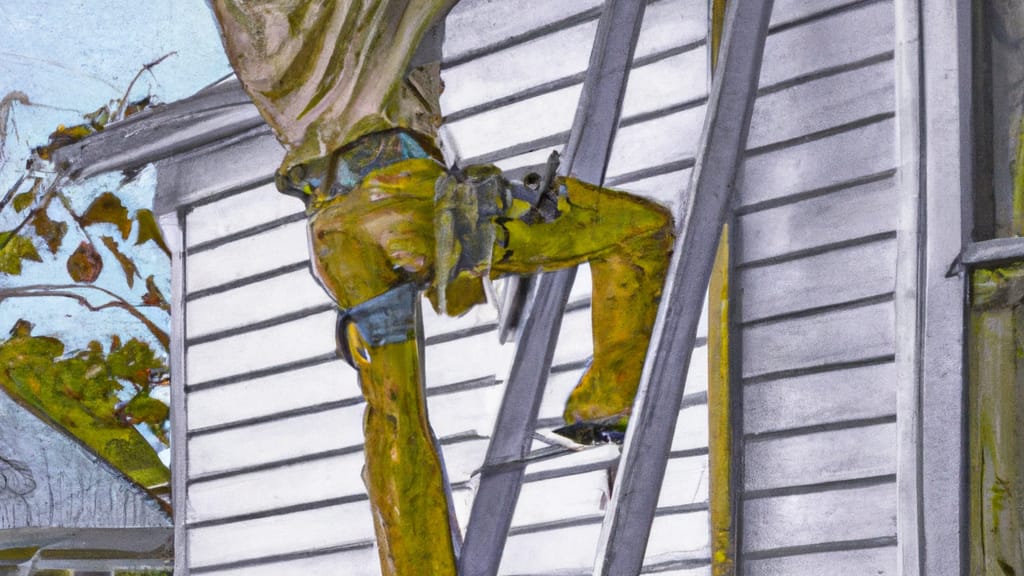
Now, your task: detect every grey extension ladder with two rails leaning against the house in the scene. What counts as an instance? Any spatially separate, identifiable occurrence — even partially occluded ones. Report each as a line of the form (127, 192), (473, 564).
(459, 0), (772, 576)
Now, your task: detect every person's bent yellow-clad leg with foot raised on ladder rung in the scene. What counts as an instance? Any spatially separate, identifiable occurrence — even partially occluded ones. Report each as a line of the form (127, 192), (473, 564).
(492, 179), (673, 425)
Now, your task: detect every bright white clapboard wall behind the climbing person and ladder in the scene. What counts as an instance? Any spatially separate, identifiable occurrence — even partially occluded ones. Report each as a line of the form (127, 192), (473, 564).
(149, 0), (710, 575)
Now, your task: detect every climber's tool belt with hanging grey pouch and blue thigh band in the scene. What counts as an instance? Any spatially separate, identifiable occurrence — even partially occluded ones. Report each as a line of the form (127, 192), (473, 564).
(276, 129), (513, 364)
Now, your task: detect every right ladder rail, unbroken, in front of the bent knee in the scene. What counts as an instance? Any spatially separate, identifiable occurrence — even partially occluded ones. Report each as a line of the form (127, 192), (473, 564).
(594, 0), (773, 576)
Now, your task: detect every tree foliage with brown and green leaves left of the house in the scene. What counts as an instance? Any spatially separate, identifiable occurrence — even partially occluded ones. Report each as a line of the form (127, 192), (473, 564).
(0, 91), (170, 488)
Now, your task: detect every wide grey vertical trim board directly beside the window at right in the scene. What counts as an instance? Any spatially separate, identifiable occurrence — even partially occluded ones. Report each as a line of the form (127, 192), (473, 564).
(920, 0), (972, 576)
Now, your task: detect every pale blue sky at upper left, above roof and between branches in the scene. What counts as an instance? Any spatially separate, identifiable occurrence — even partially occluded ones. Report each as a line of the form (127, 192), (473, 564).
(0, 0), (230, 346)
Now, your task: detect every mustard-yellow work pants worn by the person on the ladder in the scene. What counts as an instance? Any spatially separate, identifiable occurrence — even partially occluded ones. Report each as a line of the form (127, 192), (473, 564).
(309, 159), (673, 576)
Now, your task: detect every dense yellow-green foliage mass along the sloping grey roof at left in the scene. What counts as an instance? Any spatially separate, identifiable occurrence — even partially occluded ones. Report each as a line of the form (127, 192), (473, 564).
(0, 321), (170, 487)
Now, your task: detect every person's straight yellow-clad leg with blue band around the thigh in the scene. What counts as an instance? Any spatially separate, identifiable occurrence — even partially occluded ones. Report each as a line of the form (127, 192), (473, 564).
(310, 160), (456, 576)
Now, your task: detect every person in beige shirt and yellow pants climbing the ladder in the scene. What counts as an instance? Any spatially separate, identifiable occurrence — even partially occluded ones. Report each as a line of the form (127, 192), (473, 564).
(206, 0), (673, 576)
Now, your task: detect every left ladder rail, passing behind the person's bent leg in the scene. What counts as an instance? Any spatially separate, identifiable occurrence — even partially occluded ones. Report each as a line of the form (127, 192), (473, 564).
(459, 0), (646, 576)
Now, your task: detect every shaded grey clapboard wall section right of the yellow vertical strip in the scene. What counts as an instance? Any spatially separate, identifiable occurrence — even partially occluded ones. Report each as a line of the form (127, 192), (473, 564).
(732, 0), (898, 576)
